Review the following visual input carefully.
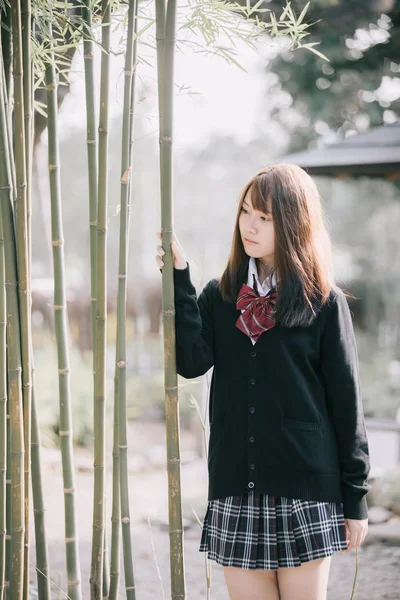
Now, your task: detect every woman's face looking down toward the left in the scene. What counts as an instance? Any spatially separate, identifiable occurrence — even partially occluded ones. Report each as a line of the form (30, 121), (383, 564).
(239, 186), (275, 264)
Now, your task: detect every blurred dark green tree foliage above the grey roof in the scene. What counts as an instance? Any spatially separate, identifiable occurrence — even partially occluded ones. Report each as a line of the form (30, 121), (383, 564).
(262, 0), (400, 151)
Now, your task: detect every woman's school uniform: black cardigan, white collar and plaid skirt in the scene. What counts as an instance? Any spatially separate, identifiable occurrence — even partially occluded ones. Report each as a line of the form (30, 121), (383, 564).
(170, 257), (371, 570)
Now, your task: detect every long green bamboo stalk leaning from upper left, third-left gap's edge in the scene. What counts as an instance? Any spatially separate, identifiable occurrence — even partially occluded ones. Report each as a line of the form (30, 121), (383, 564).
(45, 16), (82, 600)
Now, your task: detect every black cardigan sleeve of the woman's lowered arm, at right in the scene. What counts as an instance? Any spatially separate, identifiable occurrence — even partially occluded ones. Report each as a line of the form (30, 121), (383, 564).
(321, 291), (371, 519)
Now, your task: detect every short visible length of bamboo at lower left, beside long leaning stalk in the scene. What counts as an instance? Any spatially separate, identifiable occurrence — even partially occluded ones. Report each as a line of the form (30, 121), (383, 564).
(31, 384), (51, 600)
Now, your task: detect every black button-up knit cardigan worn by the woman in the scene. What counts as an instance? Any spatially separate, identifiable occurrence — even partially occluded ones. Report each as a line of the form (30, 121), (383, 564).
(173, 263), (371, 519)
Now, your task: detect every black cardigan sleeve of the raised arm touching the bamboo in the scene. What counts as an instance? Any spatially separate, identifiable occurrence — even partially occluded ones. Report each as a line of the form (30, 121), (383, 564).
(169, 263), (214, 379)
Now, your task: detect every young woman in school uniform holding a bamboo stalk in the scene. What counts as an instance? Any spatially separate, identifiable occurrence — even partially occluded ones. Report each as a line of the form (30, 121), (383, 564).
(156, 163), (371, 600)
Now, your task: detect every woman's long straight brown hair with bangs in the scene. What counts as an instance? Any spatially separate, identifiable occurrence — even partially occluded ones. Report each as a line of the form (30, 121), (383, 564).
(219, 163), (346, 327)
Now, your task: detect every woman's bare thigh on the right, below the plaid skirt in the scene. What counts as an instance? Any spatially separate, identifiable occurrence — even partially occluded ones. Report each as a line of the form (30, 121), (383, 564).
(277, 556), (331, 600)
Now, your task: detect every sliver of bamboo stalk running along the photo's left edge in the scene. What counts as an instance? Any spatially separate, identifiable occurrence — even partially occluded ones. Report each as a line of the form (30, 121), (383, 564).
(0, 178), (7, 600)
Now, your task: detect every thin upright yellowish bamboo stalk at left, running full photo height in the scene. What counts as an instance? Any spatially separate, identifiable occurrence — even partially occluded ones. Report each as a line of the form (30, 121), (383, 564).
(18, 0), (33, 600)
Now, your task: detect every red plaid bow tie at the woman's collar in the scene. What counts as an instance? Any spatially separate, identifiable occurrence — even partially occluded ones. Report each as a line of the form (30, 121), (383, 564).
(236, 276), (277, 342)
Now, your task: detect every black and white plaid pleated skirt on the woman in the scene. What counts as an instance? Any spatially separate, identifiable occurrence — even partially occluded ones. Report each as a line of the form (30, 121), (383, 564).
(199, 491), (347, 570)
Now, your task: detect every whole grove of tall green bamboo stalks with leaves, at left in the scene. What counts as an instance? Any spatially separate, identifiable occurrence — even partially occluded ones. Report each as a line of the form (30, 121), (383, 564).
(0, 0), (316, 600)
